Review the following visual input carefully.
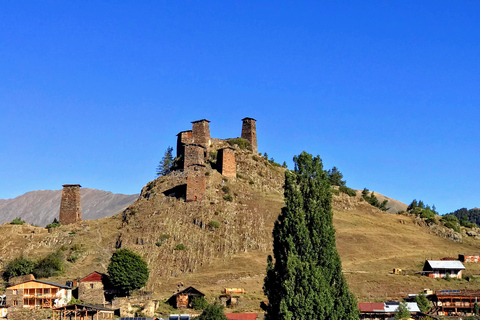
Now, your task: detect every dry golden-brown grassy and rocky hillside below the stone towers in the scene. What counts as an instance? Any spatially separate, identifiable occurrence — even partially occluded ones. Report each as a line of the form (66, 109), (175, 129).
(0, 140), (480, 310)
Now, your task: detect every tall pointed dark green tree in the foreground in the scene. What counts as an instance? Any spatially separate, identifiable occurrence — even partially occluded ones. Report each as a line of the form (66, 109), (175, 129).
(263, 152), (358, 320)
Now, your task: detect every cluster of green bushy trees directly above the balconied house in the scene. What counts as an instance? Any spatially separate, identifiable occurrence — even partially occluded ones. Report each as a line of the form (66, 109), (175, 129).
(2, 250), (65, 281)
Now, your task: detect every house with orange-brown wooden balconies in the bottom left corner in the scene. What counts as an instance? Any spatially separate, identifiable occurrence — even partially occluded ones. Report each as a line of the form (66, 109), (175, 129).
(5, 280), (72, 309)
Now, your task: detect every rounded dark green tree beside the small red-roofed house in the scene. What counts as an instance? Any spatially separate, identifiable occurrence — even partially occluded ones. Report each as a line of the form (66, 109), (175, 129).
(107, 249), (150, 294)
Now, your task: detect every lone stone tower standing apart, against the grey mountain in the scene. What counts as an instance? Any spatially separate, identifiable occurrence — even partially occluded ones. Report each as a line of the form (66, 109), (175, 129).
(58, 184), (82, 224)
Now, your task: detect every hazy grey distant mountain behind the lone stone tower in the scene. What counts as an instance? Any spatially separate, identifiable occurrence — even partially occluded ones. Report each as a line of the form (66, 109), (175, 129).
(0, 188), (138, 227)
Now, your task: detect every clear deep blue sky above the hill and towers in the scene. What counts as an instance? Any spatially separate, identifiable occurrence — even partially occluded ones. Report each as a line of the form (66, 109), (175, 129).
(0, 0), (480, 213)
